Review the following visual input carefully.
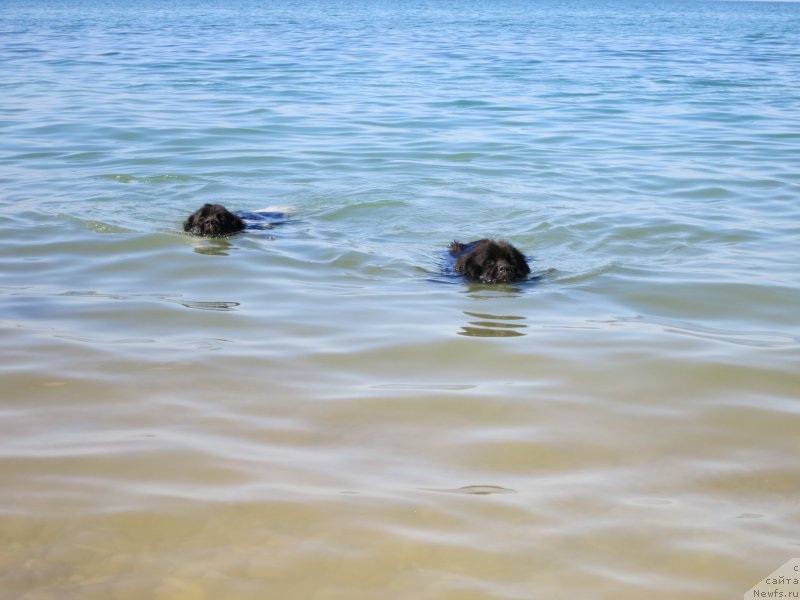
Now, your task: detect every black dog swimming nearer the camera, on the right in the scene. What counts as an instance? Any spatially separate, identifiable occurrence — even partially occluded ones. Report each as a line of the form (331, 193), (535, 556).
(450, 239), (531, 283)
